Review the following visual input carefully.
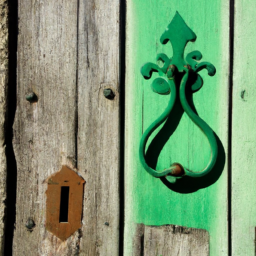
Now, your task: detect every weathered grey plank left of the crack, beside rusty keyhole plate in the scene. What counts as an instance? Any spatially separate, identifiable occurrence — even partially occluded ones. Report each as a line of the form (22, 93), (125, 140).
(13, 0), (80, 256)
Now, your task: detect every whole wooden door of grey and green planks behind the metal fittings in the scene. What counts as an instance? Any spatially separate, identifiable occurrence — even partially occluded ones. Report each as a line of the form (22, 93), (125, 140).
(0, 0), (256, 256)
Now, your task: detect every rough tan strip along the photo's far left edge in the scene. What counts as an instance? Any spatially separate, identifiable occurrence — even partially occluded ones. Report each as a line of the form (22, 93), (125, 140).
(0, 0), (9, 255)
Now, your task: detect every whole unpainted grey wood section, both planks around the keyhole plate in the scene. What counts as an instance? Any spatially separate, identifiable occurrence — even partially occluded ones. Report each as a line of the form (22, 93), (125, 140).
(13, 0), (119, 256)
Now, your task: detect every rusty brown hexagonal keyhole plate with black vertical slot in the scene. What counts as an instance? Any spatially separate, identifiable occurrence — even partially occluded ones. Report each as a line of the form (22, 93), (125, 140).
(46, 166), (85, 240)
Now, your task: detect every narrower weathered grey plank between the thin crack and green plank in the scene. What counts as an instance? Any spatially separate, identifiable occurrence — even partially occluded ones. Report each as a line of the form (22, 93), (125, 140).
(77, 0), (120, 256)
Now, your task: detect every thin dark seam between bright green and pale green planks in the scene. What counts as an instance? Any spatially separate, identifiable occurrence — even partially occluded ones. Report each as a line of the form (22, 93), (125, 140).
(228, 0), (235, 256)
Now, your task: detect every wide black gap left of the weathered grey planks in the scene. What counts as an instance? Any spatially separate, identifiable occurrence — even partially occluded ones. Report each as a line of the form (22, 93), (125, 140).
(4, 0), (18, 255)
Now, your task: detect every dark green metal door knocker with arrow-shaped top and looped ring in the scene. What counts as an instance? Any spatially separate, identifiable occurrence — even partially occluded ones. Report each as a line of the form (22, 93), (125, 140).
(139, 12), (218, 183)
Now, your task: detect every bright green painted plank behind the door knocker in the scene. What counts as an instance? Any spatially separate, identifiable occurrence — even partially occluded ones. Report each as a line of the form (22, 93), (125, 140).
(125, 0), (229, 256)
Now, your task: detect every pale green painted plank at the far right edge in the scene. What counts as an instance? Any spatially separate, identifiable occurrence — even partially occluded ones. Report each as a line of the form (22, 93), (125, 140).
(232, 0), (256, 256)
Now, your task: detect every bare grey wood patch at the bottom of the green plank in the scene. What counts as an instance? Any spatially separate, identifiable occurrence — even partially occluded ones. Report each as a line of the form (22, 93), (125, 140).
(132, 224), (210, 256)
